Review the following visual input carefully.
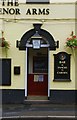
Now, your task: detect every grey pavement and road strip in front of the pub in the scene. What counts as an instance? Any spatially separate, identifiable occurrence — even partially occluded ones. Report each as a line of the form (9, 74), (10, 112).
(0, 101), (77, 120)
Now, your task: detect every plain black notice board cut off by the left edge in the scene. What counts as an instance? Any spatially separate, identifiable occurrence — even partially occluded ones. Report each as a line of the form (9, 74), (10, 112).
(0, 59), (11, 86)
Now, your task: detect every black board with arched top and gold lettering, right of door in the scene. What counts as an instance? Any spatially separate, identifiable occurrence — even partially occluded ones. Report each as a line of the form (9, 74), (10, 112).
(54, 52), (71, 81)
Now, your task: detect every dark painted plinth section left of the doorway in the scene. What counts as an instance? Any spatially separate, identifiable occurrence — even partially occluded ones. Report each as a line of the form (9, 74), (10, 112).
(2, 89), (25, 104)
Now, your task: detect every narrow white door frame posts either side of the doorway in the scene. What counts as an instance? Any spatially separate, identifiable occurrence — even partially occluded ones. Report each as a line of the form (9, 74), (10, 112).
(24, 46), (50, 98)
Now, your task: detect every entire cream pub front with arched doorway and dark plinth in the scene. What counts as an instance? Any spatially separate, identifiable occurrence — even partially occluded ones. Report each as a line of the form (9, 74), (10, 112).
(0, 0), (77, 103)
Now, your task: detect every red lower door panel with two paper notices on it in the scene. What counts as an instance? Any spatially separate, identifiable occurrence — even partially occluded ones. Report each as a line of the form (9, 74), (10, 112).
(28, 74), (48, 96)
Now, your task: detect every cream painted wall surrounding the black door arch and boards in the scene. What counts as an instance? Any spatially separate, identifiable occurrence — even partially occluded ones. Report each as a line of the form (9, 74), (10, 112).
(0, 1), (77, 90)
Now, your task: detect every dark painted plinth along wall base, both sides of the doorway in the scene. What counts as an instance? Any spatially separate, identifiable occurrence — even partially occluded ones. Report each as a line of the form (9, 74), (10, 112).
(0, 89), (77, 104)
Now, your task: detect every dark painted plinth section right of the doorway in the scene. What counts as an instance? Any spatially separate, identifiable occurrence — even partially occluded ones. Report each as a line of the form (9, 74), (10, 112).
(50, 90), (77, 104)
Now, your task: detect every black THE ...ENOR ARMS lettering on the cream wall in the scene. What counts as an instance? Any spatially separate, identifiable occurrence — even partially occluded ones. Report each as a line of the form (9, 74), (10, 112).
(0, 0), (49, 15)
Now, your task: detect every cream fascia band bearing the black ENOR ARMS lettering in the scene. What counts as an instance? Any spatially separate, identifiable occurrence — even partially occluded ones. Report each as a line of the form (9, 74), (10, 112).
(0, 0), (76, 20)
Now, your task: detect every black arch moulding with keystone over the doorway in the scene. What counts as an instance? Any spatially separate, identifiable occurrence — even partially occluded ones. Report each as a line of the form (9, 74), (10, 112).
(16, 24), (59, 50)
